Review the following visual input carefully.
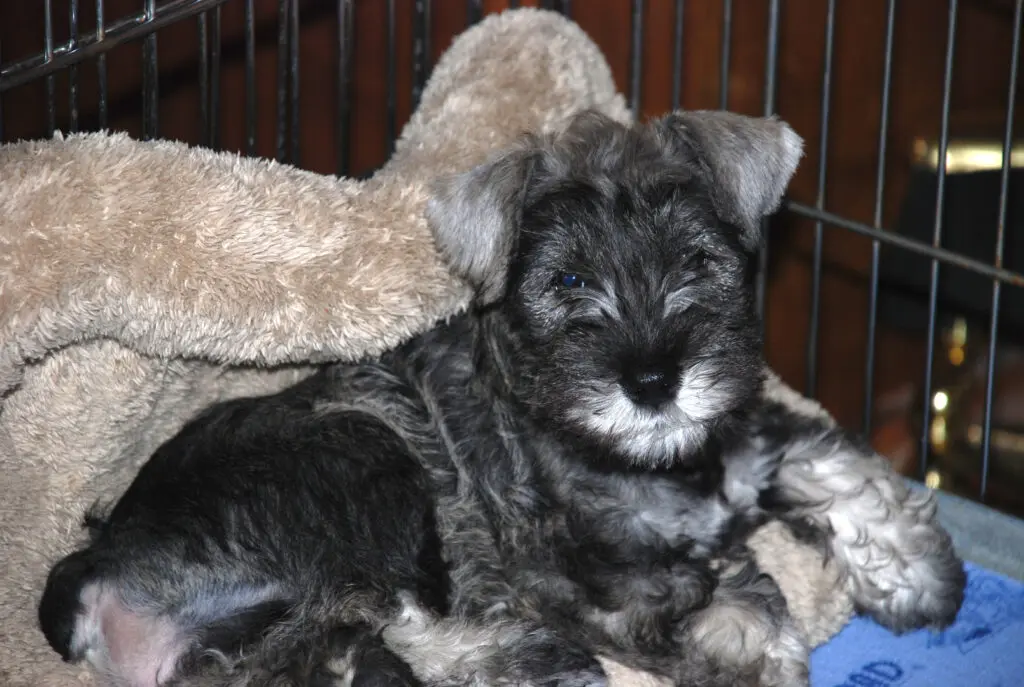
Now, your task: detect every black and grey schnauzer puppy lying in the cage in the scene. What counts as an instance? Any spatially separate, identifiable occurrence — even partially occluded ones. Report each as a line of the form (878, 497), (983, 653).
(40, 112), (965, 687)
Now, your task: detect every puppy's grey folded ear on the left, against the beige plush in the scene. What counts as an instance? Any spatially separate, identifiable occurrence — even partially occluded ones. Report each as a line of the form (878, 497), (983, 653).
(427, 146), (535, 305)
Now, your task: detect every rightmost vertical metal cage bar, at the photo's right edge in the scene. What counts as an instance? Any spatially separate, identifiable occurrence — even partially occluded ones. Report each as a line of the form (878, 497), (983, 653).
(978, 0), (1024, 502)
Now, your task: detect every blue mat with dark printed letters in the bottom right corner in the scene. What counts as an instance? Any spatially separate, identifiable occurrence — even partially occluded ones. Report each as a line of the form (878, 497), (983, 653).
(811, 564), (1024, 687)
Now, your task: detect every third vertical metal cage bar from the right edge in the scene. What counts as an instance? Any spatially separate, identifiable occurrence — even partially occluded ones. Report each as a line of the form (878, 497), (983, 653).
(863, 0), (896, 436)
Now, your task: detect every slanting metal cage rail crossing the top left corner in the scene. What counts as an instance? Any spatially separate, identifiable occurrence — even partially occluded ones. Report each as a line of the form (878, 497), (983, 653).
(0, 0), (227, 93)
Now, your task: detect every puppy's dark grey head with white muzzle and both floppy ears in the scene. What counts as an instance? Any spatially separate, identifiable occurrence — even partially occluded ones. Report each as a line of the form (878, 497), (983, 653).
(428, 112), (802, 466)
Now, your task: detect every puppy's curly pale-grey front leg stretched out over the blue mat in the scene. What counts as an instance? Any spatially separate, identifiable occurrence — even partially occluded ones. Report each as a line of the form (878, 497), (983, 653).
(726, 401), (966, 632)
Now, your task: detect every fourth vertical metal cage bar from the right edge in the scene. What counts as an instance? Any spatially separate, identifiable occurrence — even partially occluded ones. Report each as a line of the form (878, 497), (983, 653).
(804, 0), (836, 398)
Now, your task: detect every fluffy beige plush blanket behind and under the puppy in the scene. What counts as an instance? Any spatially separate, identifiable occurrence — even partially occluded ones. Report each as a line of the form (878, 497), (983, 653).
(0, 9), (850, 687)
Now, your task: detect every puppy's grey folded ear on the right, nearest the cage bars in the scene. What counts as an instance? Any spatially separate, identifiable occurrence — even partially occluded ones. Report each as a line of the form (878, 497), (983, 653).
(655, 111), (804, 250)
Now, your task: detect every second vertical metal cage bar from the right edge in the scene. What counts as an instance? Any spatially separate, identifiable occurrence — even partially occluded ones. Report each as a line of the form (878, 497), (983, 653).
(920, 0), (957, 479)
